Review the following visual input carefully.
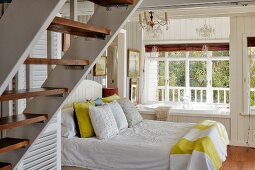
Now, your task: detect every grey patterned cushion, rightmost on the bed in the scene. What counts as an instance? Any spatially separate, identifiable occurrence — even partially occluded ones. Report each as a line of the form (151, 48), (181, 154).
(117, 98), (143, 127)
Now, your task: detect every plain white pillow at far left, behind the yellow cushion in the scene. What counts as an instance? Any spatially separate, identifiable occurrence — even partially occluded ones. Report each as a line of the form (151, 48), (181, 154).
(61, 107), (77, 138)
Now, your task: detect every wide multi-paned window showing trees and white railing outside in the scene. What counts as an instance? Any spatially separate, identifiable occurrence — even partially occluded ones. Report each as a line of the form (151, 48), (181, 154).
(145, 47), (230, 106)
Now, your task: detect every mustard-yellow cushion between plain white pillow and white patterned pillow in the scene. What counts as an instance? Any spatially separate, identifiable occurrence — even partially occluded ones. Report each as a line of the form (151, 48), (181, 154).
(74, 102), (95, 138)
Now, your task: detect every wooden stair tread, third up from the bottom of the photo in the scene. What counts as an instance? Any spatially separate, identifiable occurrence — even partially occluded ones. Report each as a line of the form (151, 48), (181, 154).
(0, 114), (48, 130)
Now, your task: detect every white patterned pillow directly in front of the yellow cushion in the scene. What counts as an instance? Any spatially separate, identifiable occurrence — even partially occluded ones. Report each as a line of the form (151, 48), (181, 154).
(89, 105), (119, 139)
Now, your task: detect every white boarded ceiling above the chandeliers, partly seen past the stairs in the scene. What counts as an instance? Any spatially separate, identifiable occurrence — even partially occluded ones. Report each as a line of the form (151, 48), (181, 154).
(61, 0), (255, 18)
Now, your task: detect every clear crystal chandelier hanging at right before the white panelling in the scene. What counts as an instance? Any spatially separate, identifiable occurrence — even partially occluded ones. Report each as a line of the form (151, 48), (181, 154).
(196, 22), (215, 56)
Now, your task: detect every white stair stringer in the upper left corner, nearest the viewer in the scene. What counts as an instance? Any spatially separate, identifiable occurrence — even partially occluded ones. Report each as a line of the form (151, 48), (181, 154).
(0, 0), (66, 95)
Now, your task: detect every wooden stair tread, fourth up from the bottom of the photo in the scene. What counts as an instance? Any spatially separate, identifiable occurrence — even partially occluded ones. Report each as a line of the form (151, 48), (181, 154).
(0, 88), (68, 101)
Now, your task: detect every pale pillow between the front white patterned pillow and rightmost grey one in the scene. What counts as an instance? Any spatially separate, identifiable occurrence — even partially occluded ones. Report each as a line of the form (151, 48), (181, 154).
(108, 100), (128, 130)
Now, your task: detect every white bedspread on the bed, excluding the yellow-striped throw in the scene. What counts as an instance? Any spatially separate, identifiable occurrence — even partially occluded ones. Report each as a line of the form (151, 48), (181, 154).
(62, 120), (194, 170)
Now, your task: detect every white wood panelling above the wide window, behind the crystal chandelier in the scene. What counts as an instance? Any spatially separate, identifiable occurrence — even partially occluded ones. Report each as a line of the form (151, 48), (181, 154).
(144, 17), (230, 43)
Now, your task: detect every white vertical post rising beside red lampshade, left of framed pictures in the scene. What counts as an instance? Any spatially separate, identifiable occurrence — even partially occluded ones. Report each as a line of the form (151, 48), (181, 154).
(117, 29), (128, 98)
